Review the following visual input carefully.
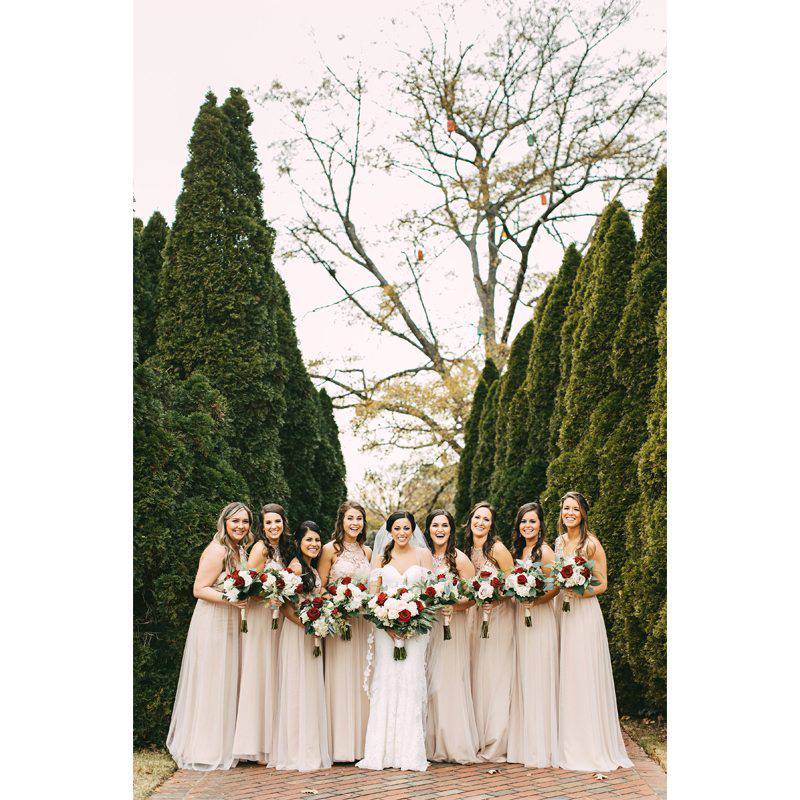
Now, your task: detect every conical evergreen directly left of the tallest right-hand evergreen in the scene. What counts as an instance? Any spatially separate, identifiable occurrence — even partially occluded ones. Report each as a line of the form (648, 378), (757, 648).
(547, 206), (636, 524)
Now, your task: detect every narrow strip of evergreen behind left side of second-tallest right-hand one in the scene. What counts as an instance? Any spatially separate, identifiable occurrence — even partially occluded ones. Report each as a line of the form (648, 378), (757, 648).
(548, 201), (622, 466)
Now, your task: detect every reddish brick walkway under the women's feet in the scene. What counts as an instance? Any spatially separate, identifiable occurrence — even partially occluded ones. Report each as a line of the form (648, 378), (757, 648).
(152, 735), (667, 800)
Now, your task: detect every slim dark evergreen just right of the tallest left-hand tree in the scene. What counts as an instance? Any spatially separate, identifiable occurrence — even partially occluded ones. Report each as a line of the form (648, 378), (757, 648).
(275, 272), (324, 522)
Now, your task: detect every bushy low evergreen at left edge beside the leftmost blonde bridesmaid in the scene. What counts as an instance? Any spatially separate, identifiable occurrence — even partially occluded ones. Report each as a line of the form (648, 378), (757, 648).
(133, 364), (247, 746)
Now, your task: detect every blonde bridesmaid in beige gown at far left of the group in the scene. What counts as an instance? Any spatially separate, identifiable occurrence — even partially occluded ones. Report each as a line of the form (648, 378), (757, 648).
(162, 503), (253, 770)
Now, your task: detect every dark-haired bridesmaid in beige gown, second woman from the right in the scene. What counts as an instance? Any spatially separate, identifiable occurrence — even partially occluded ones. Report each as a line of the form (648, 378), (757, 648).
(508, 503), (558, 768)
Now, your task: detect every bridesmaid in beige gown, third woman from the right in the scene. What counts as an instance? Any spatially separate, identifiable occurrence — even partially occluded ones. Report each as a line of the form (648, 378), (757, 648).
(464, 501), (514, 762)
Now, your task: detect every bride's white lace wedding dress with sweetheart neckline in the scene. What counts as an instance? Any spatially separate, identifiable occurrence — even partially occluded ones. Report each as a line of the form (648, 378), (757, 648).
(356, 564), (428, 772)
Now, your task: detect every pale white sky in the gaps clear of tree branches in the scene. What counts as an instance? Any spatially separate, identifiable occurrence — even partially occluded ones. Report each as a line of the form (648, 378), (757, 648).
(134, 0), (666, 490)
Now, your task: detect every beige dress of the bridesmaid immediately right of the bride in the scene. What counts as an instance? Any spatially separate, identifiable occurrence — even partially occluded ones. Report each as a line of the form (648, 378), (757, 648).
(425, 556), (480, 764)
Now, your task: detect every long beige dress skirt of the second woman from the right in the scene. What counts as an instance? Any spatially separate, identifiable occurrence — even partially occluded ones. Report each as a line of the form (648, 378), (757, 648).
(508, 601), (558, 768)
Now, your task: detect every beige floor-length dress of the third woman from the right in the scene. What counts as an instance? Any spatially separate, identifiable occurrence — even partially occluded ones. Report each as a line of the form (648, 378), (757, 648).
(467, 548), (515, 763)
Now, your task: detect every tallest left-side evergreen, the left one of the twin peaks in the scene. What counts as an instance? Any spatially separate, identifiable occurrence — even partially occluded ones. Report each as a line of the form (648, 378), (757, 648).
(157, 92), (288, 502)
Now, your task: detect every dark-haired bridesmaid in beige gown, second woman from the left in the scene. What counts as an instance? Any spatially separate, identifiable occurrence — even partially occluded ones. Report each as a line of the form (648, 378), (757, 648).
(233, 503), (294, 764)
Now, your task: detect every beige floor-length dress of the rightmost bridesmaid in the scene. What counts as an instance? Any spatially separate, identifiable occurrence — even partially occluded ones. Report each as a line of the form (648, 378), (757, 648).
(555, 536), (633, 772)
